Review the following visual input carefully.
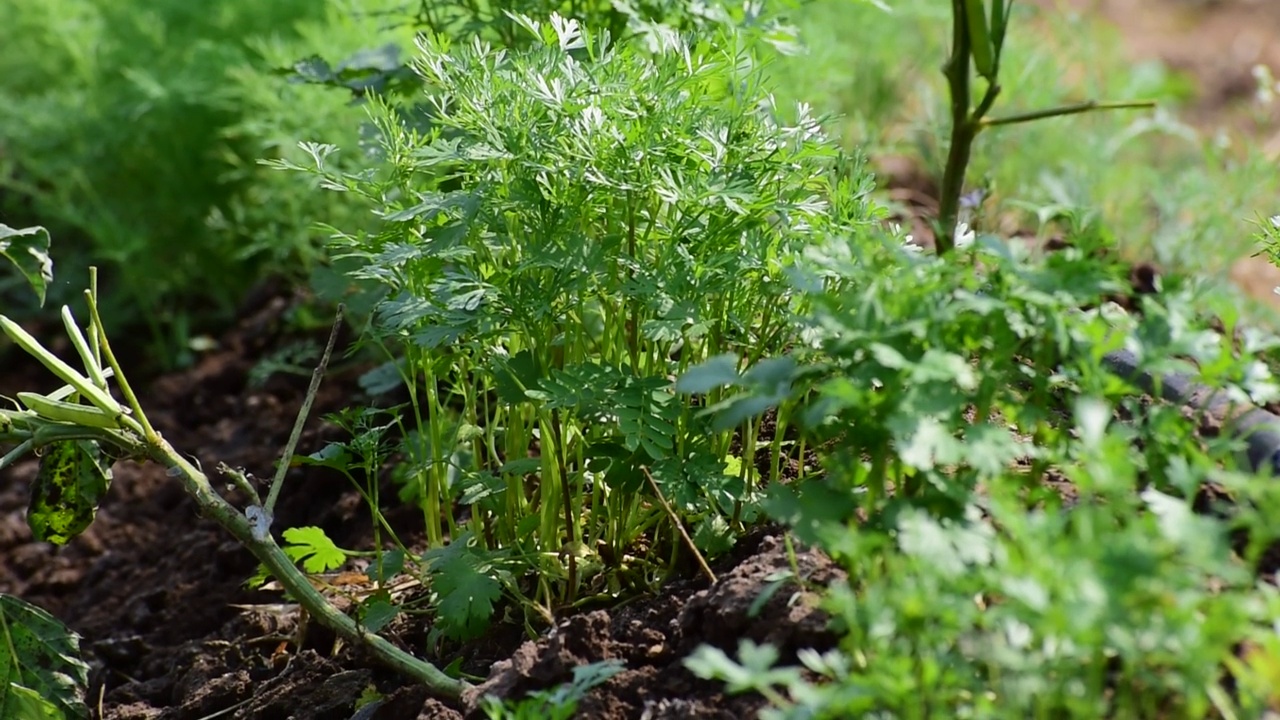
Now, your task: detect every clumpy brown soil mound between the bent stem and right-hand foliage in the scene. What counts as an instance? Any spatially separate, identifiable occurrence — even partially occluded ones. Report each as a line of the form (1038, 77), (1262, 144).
(463, 536), (841, 720)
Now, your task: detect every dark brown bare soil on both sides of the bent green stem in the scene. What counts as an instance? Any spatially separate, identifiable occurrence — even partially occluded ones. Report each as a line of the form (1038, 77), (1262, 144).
(0, 281), (838, 720)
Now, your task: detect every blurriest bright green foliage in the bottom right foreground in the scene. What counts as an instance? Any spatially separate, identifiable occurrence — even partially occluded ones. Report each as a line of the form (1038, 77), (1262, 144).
(686, 489), (1277, 719)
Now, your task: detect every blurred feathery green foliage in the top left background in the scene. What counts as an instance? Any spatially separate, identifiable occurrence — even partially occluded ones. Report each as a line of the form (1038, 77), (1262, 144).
(0, 0), (410, 366)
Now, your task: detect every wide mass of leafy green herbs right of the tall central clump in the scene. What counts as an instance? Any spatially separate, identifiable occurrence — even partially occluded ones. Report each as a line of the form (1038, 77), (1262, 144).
(682, 215), (1280, 717)
